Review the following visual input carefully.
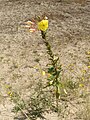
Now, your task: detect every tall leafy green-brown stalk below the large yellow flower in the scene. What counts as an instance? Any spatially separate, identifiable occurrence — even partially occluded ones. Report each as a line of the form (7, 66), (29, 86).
(41, 31), (61, 110)
